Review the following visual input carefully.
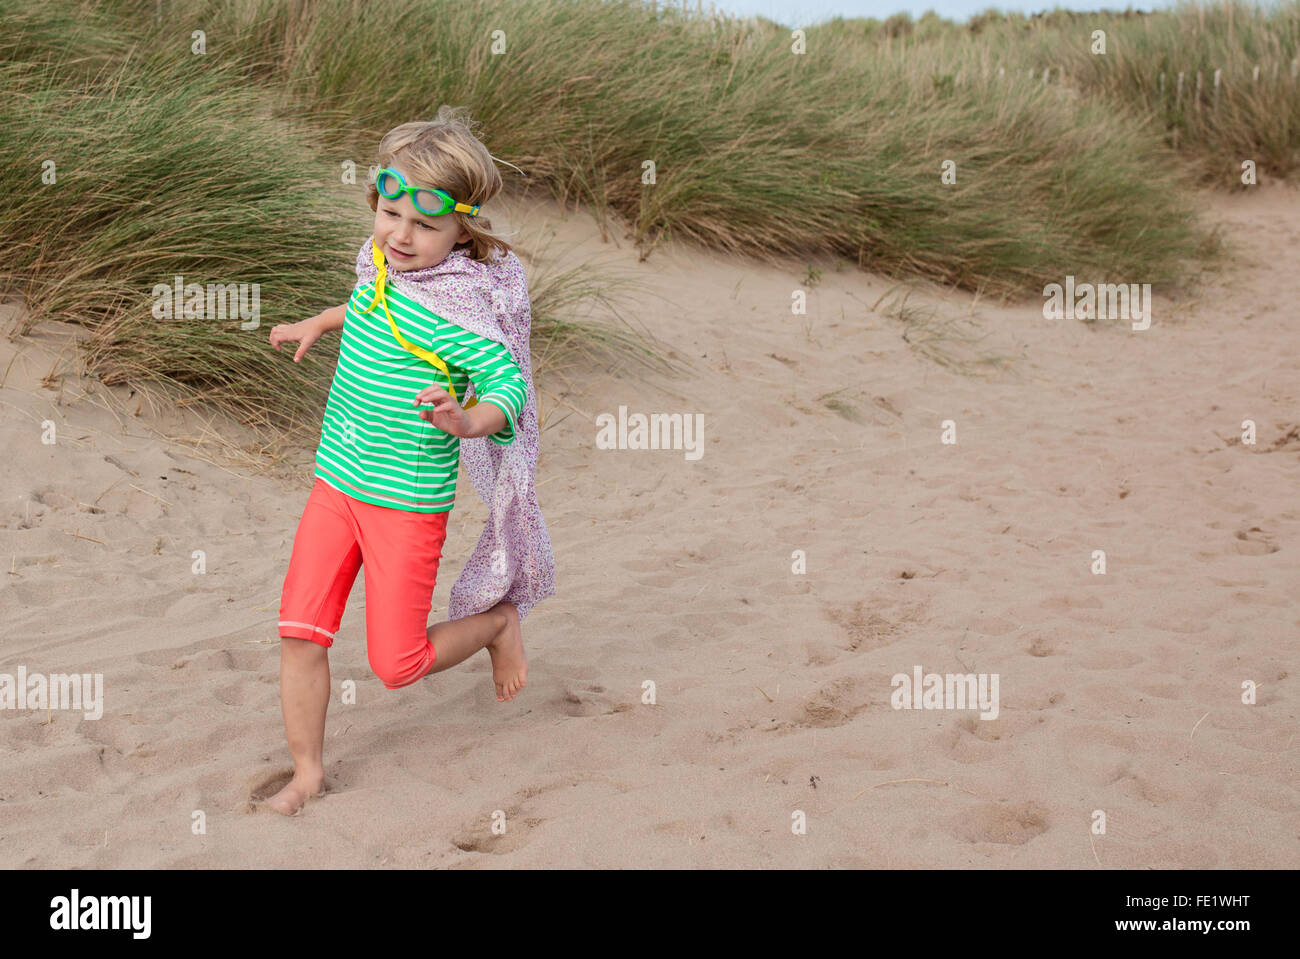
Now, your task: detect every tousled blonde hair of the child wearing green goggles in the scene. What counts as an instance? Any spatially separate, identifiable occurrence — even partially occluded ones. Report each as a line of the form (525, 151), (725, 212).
(365, 105), (511, 262)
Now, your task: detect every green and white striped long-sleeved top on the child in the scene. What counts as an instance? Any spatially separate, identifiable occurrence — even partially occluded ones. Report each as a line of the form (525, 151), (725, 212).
(315, 282), (528, 513)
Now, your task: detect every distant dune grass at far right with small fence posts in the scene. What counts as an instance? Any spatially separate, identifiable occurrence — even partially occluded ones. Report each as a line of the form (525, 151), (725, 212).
(806, 0), (1300, 188)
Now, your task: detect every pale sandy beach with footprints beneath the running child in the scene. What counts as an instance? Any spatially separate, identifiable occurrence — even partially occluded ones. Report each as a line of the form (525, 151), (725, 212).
(0, 186), (1300, 869)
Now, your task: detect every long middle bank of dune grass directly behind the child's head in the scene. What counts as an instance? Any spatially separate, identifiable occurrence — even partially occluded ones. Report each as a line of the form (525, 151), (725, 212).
(91, 0), (1206, 294)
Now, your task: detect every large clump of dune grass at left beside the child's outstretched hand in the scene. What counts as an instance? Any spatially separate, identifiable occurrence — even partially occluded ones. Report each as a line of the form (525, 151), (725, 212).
(0, 0), (358, 428)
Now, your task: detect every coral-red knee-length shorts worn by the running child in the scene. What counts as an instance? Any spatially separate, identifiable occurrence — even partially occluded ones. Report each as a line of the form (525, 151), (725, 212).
(280, 477), (449, 689)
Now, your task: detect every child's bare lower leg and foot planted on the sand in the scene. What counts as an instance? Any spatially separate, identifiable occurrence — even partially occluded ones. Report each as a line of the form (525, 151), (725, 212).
(267, 637), (329, 816)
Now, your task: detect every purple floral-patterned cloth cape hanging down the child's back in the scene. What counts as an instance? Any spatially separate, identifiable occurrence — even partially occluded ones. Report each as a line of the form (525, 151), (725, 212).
(356, 237), (555, 621)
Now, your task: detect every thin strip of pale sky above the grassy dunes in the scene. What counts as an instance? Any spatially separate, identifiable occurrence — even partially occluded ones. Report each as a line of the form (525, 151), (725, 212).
(696, 0), (1171, 27)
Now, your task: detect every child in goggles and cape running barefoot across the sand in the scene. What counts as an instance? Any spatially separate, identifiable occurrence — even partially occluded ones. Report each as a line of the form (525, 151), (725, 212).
(267, 107), (555, 815)
